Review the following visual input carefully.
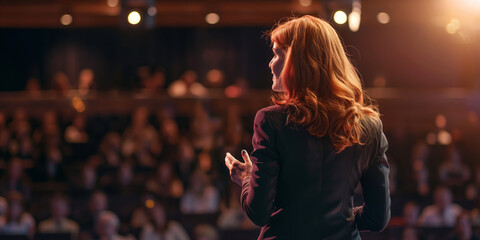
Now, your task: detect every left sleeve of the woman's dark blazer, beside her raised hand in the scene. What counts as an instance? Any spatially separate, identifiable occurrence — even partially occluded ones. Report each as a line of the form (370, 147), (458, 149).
(241, 110), (279, 226)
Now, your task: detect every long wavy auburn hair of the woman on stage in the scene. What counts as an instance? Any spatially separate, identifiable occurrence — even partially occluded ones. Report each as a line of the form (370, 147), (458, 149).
(268, 15), (380, 152)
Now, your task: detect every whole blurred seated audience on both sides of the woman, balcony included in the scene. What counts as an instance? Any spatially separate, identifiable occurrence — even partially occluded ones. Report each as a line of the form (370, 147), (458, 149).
(0, 67), (480, 240)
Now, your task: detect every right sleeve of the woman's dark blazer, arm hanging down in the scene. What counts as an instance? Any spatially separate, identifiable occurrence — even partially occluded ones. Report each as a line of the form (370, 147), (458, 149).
(354, 123), (390, 231)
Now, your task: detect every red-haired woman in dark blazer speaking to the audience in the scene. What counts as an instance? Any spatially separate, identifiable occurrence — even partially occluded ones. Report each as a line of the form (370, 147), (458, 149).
(225, 16), (390, 239)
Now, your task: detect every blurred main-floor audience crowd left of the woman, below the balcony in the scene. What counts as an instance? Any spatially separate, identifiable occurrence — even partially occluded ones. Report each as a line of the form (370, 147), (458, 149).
(0, 101), (257, 240)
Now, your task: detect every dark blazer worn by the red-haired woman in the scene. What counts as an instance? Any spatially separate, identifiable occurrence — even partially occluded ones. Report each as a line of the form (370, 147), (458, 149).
(241, 106), (390, 240)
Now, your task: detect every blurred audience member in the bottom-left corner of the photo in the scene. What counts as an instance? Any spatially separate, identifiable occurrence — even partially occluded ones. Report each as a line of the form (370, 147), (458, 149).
(0, 192), (35, 238)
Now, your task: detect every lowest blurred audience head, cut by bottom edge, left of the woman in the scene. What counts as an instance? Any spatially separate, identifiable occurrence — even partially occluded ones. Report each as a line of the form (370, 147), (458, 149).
(95, 211), (135, 240)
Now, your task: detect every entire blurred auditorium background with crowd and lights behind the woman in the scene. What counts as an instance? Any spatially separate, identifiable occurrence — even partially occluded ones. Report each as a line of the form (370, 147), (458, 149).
(0, 0), (480, 240)
